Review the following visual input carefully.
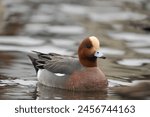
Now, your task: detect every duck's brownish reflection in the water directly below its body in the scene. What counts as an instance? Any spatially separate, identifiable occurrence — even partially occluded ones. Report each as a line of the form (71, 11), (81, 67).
(37, 83), (107, 100)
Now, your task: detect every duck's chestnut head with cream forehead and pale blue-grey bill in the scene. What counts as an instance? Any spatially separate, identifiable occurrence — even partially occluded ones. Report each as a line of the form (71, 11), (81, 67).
(78, 36), (105, 67)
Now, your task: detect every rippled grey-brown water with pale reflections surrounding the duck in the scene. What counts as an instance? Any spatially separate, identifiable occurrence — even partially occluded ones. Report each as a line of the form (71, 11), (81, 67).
(0, 0), (150, 100)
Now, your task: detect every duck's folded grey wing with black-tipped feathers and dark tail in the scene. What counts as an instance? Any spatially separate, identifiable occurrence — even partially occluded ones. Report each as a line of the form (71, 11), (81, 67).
(29, 51), (81, 74)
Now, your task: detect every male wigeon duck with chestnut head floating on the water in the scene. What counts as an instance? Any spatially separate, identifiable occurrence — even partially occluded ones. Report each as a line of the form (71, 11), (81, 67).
(29, 36), (108, 91)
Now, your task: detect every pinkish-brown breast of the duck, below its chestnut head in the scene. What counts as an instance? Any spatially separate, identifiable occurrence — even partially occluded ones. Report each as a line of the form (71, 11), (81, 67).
(66, 67), (108, 91)
